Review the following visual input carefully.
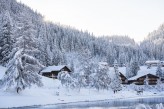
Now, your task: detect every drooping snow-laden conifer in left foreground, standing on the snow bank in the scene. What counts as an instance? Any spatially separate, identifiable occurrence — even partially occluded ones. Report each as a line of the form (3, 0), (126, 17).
(3, 49), (42, 93)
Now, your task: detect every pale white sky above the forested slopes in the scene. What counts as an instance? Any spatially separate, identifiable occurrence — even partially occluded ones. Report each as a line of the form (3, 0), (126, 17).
(17, 0), (164, 41)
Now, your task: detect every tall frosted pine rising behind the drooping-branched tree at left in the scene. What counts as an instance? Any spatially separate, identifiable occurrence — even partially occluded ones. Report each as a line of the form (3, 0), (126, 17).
(15, 13), (40, 57)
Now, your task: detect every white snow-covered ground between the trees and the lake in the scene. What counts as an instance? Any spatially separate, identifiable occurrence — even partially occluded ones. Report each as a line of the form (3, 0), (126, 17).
(0, 77), (164, 108)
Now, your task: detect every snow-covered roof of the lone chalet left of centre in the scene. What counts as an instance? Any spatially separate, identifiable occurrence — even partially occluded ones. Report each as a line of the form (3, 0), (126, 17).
(41, 65), (68, 73)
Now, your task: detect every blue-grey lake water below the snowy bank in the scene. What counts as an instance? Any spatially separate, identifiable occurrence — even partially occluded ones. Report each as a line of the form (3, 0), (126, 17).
(10, 97), (164, 109)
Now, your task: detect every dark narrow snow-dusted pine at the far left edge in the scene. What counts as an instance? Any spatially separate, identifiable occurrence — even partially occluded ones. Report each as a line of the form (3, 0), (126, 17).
(0, 11), (13, 66)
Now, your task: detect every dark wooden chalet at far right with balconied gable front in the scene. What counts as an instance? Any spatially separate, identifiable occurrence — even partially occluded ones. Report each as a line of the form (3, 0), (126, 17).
(128, 73), (159, 85)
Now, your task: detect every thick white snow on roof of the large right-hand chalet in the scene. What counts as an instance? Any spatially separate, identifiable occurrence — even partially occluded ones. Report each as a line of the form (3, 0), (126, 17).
(128, 66), (160, 80)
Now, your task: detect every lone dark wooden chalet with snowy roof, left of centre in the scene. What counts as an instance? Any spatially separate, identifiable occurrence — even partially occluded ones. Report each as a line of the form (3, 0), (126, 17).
(40, 65), (71, 79)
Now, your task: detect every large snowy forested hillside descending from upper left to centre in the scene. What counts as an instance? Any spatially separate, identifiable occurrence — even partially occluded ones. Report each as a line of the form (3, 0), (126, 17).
(0, 0), (142, 66)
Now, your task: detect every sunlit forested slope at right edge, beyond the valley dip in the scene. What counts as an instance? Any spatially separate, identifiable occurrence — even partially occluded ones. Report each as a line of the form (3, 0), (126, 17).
(141, 24), (164, 60)
